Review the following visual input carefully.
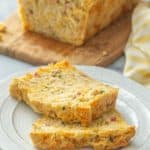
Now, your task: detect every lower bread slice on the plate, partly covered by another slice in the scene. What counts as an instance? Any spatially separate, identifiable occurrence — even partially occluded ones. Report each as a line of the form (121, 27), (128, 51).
(31, 110), (135, 150)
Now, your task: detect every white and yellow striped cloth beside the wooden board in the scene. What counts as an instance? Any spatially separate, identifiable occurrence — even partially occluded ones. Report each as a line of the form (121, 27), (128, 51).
(124, 2), (150, 88)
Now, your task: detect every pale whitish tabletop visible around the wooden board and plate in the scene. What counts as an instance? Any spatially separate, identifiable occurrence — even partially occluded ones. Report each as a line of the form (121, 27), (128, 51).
(0, 0), (125, 80)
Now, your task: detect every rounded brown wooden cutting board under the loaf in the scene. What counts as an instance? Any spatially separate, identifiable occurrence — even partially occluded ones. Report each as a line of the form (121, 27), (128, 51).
(0, 13), (131, 66)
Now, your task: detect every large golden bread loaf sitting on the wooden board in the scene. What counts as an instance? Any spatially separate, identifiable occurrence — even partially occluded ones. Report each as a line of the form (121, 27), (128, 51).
(19, 0), (139, 45)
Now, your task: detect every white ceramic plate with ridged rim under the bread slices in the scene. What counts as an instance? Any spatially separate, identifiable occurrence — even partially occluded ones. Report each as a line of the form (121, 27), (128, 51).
(0, 66), (150, 150)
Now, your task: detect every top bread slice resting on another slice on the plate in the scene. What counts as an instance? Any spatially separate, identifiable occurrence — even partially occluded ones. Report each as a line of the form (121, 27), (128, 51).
(10, 61), (118, 126)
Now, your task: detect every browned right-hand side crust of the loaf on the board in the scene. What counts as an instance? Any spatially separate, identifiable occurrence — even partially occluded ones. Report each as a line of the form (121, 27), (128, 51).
(85, 0), (139, 39)
